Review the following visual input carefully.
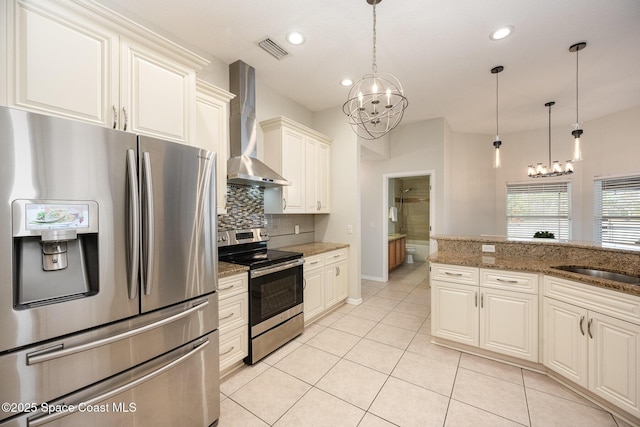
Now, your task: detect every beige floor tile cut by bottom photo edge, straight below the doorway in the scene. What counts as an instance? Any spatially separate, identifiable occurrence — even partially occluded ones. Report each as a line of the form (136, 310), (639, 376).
(369, 377), (449, 427)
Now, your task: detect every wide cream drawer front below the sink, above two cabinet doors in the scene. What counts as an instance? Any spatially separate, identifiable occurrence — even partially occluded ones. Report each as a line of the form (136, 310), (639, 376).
(544, 276), (640, 325)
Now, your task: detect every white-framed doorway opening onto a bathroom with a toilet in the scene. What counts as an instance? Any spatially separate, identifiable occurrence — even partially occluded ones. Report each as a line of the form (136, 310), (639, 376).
(383, 171), (435, 281)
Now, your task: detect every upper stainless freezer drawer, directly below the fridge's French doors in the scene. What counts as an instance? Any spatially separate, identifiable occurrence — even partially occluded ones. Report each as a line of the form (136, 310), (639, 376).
(0, 293), (218, 420)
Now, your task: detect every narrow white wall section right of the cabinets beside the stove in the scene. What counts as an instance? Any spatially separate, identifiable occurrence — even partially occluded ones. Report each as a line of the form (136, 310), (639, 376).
(310, 108), (362, 304)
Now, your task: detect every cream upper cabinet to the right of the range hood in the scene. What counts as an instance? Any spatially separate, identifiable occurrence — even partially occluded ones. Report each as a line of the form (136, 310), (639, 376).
(260, 117), (331, 213)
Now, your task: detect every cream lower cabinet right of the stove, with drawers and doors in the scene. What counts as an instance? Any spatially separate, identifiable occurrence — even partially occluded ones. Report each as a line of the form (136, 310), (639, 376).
(304, 248), (349, 323)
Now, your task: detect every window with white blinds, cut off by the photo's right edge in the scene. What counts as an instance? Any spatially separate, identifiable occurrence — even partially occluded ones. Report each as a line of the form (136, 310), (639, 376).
(593, 176), (640, 249)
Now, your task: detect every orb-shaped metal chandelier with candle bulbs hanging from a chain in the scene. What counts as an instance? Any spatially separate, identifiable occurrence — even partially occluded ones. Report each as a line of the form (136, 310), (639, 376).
(342, 0), (409, 139)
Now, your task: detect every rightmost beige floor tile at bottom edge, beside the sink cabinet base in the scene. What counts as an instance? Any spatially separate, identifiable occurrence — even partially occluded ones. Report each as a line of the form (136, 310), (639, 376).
(527, 389), (617, 427)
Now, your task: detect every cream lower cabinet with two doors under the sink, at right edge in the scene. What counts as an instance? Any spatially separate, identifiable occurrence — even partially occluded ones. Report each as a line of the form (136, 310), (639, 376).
(542, 276), (640, 417)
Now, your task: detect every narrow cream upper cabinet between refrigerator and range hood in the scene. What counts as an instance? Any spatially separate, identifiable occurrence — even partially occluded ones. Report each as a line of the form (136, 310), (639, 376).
(194, 80), (234, 215)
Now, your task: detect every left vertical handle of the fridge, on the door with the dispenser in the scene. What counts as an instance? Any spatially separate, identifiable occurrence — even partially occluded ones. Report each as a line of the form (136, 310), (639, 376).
(127, 149), (140, 299)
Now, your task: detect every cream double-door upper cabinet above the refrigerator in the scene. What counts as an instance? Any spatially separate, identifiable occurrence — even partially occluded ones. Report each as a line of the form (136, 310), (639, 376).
(6, 0), (207, 143)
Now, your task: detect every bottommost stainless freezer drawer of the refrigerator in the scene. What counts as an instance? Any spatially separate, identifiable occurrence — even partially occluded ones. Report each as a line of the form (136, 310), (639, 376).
(0, 330), (220, 427)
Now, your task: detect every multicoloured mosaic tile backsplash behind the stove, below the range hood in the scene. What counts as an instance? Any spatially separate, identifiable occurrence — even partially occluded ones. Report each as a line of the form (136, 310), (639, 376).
(218, 184), (265, 231)
